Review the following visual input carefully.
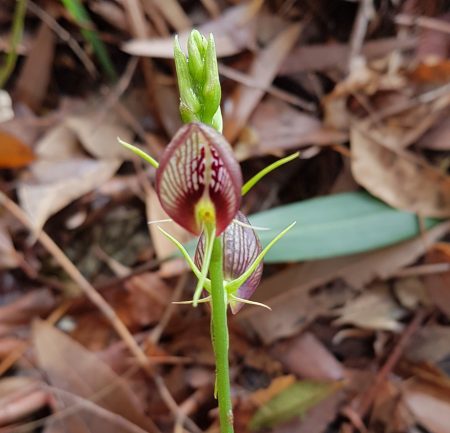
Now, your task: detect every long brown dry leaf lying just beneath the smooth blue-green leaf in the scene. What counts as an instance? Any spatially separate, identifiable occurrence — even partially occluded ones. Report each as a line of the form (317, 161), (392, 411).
(235, 222), (450, 344)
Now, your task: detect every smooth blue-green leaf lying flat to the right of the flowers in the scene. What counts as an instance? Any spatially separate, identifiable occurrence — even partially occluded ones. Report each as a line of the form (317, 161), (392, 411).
(249, 191), (439, 263)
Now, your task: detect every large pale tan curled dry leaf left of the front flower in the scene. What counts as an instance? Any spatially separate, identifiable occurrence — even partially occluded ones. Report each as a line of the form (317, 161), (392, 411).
(18, 103), (132, 228)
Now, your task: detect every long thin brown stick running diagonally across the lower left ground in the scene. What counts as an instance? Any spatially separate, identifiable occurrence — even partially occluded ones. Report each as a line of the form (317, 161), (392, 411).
(0, 191), (201, 433)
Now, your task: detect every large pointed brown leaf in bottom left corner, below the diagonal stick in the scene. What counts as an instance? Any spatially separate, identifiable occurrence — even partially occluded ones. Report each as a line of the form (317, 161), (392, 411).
(33, 322), (154, 432)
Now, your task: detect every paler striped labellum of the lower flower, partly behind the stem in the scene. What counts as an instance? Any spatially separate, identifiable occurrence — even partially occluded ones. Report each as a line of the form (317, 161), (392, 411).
(194, 211), (263, 314)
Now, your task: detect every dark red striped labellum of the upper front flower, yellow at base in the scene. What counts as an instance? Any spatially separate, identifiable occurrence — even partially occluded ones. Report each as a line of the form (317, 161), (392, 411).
(156, 123), (242, 236)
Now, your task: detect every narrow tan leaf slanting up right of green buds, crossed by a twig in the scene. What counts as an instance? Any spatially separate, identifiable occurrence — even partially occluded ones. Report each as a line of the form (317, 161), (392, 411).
(223, 23), (302, 142)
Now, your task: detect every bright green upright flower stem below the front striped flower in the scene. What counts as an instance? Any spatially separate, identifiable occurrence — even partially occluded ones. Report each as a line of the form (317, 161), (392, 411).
(209, 237), (234, 433)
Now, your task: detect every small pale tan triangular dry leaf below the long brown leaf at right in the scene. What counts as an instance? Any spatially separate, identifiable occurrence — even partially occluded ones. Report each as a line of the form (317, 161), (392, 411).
(334, 283), (407, 332)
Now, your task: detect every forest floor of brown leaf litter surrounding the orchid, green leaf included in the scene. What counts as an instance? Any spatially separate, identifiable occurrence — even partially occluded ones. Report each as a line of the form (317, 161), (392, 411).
(0, 0), (450, 433)
